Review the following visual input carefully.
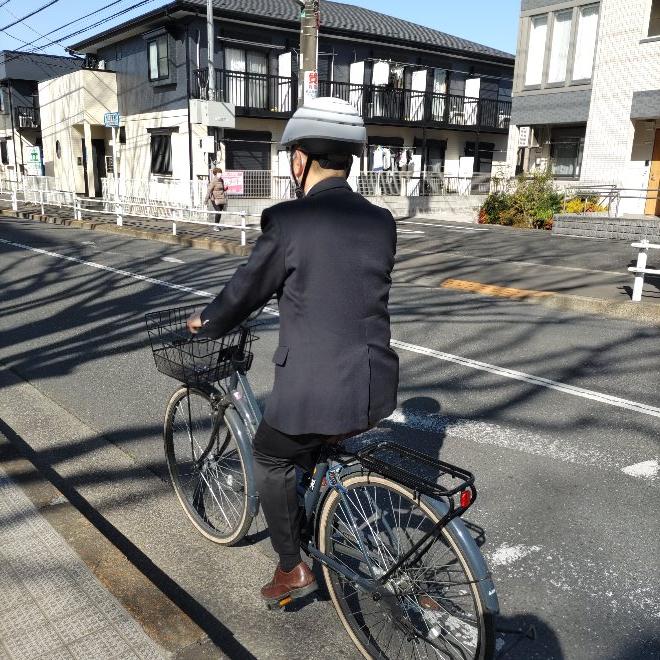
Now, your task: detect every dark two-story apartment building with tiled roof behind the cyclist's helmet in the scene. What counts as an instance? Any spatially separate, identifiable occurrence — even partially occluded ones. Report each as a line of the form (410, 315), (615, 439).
(42, 0), (514, 199)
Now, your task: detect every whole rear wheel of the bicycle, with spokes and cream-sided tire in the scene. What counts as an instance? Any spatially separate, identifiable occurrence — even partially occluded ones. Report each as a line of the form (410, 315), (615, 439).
(318, 474), (495, 660)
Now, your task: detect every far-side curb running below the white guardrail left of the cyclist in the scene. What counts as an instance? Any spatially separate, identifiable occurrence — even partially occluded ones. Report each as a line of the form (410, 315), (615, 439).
(0, 209), (252, 257)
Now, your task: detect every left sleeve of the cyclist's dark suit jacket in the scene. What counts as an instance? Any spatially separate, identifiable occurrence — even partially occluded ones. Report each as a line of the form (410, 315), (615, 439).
(201, 211), (286, 338)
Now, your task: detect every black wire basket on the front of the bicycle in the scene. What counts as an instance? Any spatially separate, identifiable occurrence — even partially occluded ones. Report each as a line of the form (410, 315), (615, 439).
(145, 306), (257, 387)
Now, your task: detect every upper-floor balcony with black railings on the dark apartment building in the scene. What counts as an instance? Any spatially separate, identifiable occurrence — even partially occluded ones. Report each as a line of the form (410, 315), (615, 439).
(193, 69), (511, 133)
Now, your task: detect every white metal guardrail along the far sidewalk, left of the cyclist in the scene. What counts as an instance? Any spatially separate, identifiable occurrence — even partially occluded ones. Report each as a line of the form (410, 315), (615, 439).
(0, 177), (261, 245)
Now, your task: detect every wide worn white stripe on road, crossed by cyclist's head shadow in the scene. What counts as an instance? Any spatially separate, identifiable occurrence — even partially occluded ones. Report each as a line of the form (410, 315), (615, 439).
(378, 408), (657, 482)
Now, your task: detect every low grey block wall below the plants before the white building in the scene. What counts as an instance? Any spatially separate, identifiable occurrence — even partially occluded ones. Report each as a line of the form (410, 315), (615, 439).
(552, 214), (660, 243)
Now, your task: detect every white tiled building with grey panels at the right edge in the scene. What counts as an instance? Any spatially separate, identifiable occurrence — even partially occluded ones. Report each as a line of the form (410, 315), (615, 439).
(509, 0), (660, 214)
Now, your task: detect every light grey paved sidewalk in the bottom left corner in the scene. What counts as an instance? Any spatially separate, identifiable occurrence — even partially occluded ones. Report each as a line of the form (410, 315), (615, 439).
(0, 452), (168, 660)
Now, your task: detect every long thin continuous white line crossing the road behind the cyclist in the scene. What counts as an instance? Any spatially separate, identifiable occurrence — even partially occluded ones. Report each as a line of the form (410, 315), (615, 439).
(5, 238), (660, 418)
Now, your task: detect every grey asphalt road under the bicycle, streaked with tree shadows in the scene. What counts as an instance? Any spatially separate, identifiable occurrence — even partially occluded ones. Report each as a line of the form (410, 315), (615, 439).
(0, 219), (660, 660)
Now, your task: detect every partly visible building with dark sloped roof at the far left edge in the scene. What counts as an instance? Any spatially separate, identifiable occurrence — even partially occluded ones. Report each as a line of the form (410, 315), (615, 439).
(0, 50), (81, 180)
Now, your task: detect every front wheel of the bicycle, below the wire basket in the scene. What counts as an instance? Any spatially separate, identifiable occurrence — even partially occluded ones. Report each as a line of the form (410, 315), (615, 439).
(163, 387), (253, 546)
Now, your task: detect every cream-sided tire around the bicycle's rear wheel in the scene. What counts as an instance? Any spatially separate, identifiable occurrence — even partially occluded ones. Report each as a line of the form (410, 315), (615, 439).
(317, 473), (495, 660)
